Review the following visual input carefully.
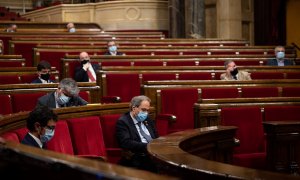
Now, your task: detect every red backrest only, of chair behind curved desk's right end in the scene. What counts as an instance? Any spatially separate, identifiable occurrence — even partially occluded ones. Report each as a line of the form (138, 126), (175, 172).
(221, 107), (265, 154)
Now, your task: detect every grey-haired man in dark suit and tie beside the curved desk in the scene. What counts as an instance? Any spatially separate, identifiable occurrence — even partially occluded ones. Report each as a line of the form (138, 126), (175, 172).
(116, 96), (158, 172)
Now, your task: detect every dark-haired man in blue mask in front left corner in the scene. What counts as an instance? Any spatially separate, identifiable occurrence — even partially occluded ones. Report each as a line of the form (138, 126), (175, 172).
(21, 106), (57, 149)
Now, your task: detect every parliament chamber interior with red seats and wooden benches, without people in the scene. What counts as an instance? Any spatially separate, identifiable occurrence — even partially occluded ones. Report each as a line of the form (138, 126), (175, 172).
(0, 0), (300, 180)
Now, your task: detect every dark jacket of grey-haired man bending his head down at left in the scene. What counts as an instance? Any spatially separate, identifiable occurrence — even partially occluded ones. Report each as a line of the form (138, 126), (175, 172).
(37, 92), (87, 108)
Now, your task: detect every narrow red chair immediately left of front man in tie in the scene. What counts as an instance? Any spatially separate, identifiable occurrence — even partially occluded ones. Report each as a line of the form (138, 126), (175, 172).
(100, 114), (121, 163)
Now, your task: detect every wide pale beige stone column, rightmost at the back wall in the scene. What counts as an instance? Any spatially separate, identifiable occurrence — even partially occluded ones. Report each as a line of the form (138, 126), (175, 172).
(217, 0), (242, 39)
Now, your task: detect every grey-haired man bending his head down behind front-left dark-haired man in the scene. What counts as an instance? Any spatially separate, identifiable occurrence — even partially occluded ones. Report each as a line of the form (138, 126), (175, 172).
(37, 78), (87, 108)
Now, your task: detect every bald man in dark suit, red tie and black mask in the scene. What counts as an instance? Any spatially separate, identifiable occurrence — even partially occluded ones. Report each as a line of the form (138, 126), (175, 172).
(74, 52), (100, 82)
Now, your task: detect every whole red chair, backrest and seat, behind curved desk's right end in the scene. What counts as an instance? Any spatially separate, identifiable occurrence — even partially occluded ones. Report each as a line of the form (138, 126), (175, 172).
(221, 107), (266, 169)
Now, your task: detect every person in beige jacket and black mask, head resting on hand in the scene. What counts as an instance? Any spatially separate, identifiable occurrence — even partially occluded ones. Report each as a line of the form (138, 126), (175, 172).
(220, 60), (251, 81)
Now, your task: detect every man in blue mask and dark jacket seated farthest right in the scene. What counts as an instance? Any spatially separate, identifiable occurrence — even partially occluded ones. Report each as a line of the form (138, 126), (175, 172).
(267, 46), (295, 66)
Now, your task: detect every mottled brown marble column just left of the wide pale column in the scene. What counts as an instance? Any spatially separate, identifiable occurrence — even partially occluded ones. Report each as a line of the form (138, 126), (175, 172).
(185, 0), (205, 39)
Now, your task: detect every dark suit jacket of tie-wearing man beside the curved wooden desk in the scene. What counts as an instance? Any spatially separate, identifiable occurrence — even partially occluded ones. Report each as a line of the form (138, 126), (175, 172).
(116, 112), (158, 153)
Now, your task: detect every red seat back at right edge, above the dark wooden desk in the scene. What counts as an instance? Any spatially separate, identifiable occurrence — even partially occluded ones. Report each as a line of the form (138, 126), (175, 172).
(264, 106), (300, 121)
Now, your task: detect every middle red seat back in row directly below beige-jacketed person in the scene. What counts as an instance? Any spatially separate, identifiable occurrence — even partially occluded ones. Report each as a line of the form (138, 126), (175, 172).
(242, 87), (279, 98)
